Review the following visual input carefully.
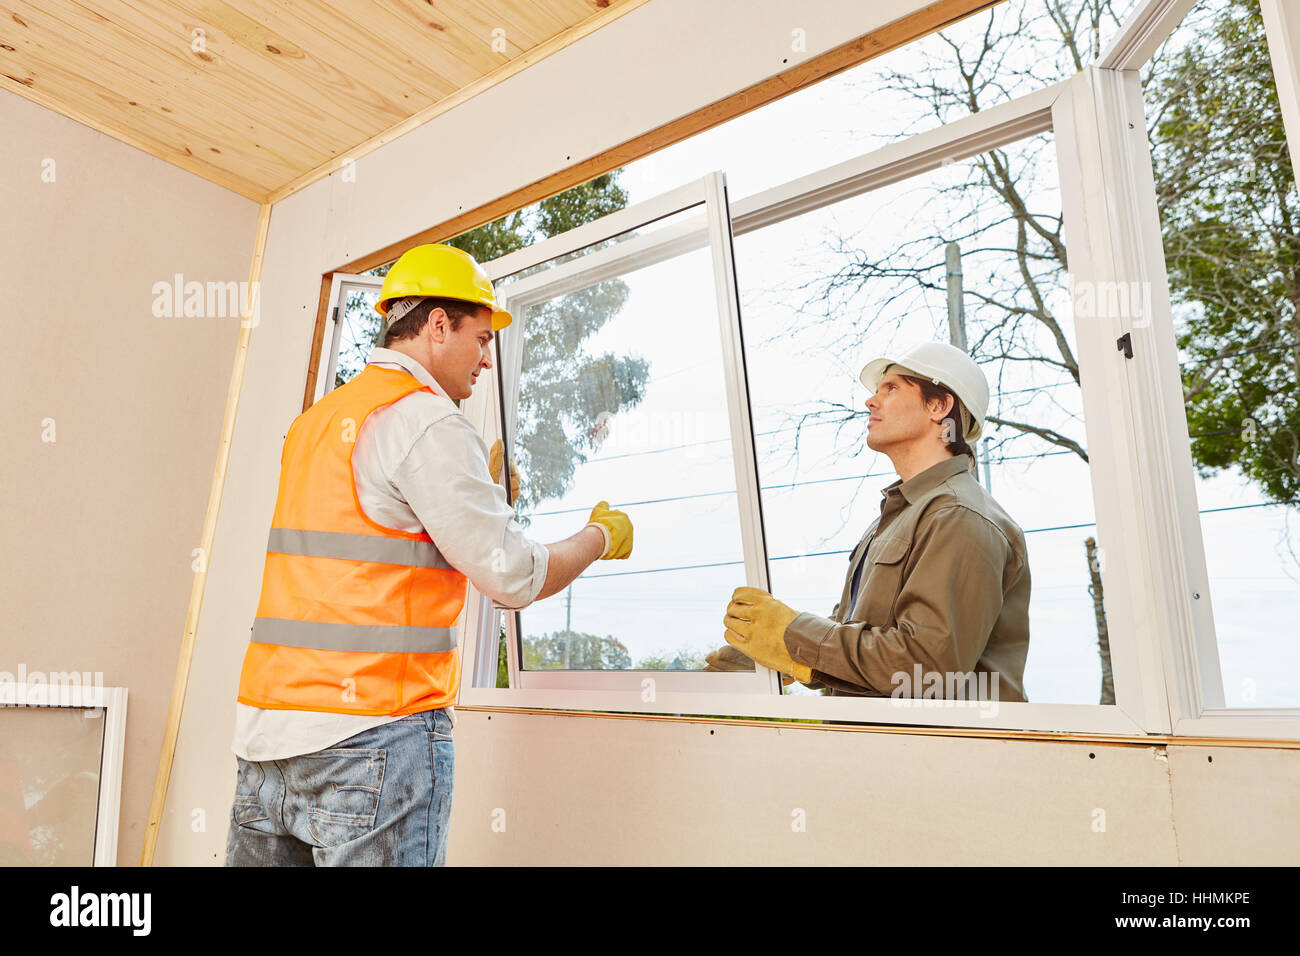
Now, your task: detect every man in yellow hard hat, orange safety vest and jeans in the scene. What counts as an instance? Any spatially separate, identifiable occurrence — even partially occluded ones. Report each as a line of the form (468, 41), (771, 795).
(226, 245), (632, 866)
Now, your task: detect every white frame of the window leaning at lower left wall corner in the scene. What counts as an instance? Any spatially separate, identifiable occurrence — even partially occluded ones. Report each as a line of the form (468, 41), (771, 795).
(0, 682), (126, 866)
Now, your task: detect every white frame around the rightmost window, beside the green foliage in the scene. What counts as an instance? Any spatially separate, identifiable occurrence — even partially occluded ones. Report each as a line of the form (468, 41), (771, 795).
(1092, 0), (1300, 739)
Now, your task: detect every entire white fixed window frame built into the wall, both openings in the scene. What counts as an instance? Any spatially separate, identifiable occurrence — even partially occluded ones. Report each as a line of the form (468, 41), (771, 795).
(301, 0), (1300, 740)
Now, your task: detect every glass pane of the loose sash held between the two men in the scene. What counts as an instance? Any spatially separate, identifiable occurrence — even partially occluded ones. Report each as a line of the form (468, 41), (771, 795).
(511, 208), (745, 670)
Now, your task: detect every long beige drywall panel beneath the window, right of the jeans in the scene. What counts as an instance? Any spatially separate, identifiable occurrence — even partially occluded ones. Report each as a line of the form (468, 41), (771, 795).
(447, 710), (1190, 866)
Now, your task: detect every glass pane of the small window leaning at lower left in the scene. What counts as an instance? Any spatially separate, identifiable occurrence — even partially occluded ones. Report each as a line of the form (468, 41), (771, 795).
(0, 706), (104, 866)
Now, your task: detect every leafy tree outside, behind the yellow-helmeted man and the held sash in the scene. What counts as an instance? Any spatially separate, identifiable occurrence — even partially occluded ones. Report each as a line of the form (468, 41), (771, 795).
(335, 170), (650, 515)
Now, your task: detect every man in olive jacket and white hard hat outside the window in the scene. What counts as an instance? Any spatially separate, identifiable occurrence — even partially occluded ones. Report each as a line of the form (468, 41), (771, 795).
(707, 342), (1030, 701)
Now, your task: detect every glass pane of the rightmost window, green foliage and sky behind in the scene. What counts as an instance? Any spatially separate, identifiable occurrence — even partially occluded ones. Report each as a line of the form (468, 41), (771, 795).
(1144, 0), (1300, 708)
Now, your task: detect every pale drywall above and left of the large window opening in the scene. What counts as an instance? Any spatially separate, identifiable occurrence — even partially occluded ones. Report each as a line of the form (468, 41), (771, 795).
(155, 0), (967, 865)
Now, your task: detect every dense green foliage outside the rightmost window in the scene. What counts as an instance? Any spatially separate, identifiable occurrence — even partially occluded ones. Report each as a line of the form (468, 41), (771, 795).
(1147, 0), (1300, 501)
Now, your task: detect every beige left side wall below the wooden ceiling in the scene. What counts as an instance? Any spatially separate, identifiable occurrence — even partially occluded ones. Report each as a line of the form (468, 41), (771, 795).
(0, 91), (257, 864)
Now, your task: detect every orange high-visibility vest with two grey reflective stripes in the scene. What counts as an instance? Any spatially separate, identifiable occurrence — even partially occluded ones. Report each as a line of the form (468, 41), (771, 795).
(239, 365), (467, 715)
